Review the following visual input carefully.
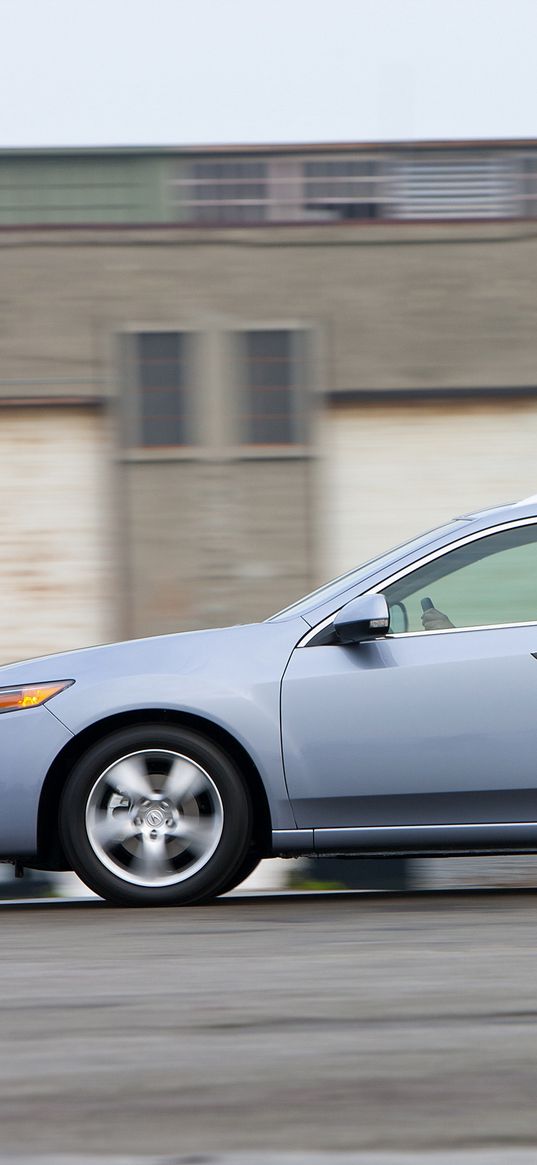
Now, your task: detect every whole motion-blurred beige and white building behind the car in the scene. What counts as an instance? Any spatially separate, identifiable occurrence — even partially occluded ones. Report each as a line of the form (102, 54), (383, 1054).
(0, 141), (537, 661)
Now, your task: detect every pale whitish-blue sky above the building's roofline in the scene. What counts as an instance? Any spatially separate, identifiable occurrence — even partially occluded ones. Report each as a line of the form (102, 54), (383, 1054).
(0, 0), (537, 147)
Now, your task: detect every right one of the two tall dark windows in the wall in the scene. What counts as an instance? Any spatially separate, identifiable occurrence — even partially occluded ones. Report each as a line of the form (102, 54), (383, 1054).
(241, 330), (305, 445)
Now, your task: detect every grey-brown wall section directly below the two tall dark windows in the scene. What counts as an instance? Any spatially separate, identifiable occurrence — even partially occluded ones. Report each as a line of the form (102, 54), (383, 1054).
(123, 459), (313, 635)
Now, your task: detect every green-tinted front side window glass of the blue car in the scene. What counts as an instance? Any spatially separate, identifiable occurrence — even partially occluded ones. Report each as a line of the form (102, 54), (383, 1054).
(383, 525), (537, 634)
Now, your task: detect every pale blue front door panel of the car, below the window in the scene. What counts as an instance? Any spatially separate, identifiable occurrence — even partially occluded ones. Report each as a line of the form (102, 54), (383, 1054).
(282, 626), (537, 849)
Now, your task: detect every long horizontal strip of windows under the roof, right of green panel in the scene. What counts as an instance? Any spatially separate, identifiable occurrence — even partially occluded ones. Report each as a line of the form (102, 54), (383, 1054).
(167, 147), (537, 226)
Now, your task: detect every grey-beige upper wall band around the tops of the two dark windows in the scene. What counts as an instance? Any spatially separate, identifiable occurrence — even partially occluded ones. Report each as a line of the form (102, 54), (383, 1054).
(0, 223), (537, 389)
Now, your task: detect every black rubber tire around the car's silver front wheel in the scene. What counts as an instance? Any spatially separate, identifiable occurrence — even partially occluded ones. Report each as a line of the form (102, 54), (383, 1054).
(59, 723), (252, 906)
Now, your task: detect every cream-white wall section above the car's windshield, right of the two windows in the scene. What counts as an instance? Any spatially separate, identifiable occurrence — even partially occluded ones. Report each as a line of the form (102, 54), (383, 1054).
(319, 398), (537, 578)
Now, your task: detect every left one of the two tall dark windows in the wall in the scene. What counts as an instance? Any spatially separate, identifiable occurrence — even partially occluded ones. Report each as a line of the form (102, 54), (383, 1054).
(133, 332), (195, 449)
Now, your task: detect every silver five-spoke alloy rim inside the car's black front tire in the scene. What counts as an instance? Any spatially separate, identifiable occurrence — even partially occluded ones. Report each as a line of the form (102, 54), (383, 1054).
(86, 749), (224, 888)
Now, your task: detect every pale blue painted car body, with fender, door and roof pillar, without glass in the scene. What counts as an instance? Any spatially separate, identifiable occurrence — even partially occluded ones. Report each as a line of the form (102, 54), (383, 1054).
(0, 502), (537, 859)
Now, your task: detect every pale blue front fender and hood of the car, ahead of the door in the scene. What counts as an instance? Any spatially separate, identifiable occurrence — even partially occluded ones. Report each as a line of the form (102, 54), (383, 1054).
(0, 616), (308, 855)
